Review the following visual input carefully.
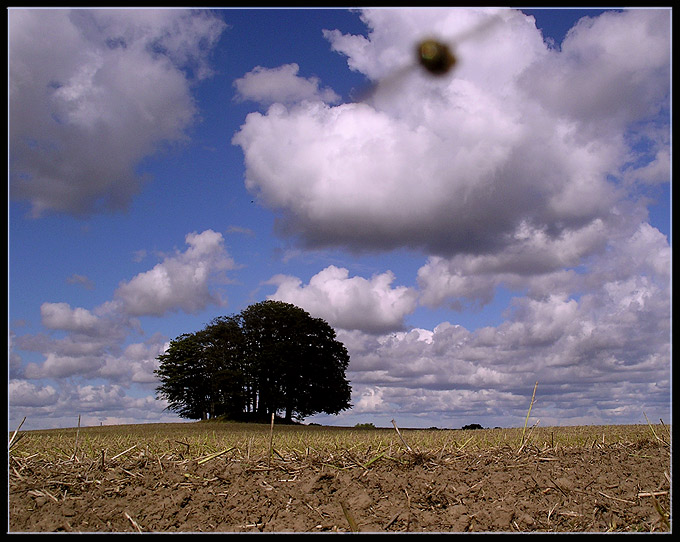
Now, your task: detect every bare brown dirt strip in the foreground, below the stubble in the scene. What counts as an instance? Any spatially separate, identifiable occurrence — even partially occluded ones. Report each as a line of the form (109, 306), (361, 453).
(9, 440), (670, 532)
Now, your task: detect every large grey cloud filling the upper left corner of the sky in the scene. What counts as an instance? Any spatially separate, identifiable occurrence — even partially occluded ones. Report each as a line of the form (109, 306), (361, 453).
(8, 9), (225, 216)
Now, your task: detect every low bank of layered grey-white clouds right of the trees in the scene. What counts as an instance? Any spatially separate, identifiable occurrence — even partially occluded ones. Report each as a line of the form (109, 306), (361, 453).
(338, 266), (671, 427)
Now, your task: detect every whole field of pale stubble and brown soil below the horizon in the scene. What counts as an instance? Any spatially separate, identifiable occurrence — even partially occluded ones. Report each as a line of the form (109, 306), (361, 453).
(8, 422), (671, 533)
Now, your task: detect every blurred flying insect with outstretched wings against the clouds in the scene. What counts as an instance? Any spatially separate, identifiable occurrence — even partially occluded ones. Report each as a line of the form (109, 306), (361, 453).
(361, 15), (502, 101)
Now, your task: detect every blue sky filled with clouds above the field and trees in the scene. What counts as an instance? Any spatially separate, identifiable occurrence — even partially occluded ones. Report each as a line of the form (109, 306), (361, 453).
(7, 8), (672, 430)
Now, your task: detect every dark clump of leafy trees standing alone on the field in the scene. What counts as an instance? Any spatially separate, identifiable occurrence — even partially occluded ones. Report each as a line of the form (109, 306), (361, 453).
(155, 301), (352, 421)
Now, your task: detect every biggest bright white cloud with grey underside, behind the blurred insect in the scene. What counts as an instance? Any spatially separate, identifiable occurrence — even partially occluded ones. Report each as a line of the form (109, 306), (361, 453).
(233, 9), (669, 257)
